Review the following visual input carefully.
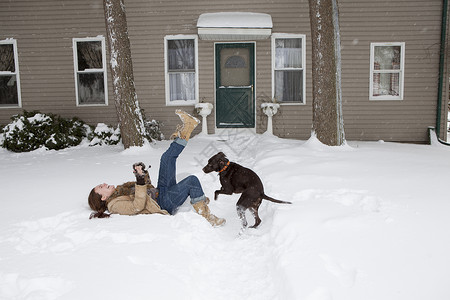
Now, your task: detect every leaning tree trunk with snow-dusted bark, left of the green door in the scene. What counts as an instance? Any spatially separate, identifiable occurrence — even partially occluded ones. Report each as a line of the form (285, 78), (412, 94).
(103, 0), (145, 149)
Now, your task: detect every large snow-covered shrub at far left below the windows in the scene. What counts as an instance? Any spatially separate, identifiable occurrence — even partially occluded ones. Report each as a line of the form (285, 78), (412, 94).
(1, 111), (89, 152)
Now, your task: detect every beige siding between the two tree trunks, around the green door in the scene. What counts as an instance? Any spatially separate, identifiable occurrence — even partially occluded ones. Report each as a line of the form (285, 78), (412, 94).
(126, 0), (311, 138)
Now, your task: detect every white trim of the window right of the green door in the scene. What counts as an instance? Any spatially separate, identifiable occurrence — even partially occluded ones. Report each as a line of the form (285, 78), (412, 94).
(272, 33), (306, 105)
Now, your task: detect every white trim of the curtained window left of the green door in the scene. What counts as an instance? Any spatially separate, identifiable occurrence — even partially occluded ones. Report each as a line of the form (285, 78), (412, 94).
(164, 34), (199, 106)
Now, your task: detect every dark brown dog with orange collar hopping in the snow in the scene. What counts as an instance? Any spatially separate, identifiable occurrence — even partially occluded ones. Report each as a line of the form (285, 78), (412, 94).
(203, 152), (292, 228)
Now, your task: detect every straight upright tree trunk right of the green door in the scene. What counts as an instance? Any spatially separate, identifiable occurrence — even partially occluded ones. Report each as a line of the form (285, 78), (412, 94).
(309, 0), (345, 146)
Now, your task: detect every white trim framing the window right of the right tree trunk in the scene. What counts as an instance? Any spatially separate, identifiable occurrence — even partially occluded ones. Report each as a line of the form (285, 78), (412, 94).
(369, 42), (405, 100)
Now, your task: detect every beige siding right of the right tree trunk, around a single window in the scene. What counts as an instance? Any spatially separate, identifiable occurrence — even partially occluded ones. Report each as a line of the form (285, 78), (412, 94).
(339, 0), (442, 142)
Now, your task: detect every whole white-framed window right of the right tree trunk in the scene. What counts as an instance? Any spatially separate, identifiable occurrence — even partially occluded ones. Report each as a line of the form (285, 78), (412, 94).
(369, 43), (405, 100)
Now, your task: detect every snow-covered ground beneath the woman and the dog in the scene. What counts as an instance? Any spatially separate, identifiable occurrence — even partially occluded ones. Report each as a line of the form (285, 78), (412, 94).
(0, 135), (450, 300)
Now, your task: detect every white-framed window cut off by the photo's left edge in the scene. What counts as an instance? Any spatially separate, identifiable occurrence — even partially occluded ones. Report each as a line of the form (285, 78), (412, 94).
(0, 39), (21, 108)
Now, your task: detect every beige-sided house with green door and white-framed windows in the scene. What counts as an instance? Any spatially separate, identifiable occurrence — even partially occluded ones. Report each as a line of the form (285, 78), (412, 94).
(0, 0), (448, 143)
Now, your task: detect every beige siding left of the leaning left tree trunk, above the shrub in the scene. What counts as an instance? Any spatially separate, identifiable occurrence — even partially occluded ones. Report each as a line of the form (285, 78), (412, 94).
(0, 0), (117, 124)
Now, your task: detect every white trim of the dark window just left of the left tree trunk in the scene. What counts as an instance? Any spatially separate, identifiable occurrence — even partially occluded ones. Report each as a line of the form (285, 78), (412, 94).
(72, 36), (108, 107)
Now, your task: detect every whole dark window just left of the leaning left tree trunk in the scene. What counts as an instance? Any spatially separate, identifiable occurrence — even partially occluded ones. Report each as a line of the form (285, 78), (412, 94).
(73, 37), (108, 105)
